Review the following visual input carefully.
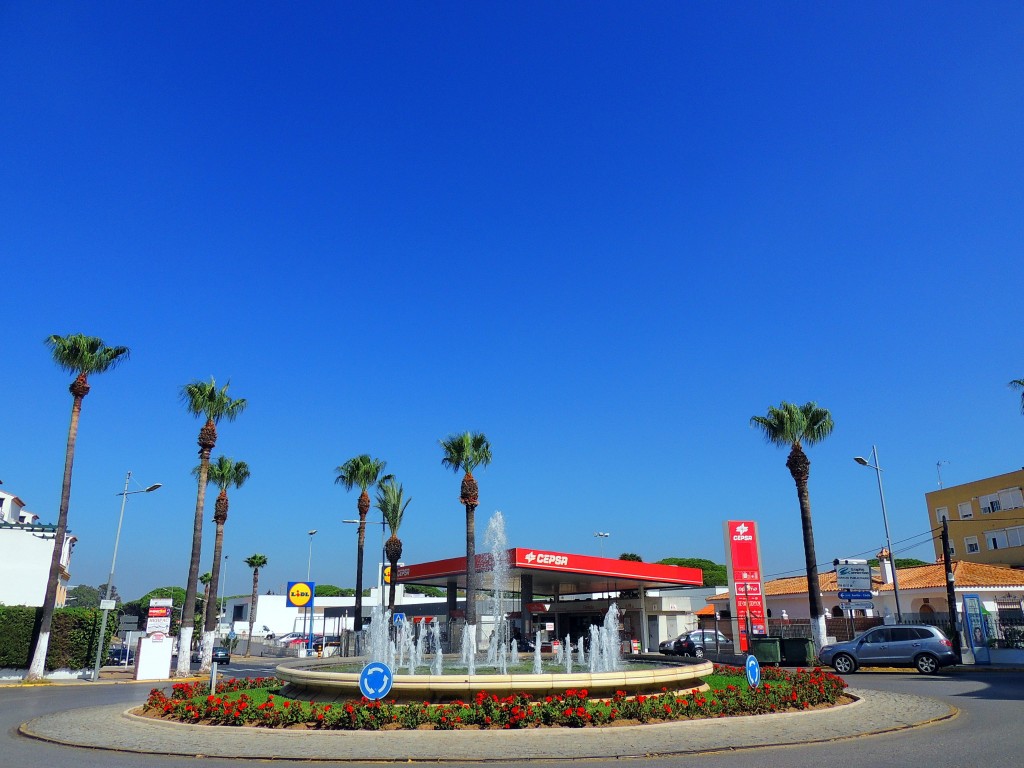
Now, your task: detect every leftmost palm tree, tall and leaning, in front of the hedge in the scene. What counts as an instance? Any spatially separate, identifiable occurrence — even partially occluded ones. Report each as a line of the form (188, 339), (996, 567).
(26, 334), (129, 680)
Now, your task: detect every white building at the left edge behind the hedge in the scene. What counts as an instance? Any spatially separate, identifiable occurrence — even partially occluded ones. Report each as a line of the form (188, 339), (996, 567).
(0, 490), (77, 607)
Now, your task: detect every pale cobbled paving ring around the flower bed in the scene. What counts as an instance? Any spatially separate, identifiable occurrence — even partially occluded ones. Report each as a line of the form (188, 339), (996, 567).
(19, 688), (957, 762)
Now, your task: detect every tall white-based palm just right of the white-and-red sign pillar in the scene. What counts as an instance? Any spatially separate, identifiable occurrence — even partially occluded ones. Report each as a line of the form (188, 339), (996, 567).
(175, 377), (248, 677)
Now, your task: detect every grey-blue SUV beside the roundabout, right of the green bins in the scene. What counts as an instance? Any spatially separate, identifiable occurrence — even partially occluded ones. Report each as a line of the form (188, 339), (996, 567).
(818, 624), (959, 675)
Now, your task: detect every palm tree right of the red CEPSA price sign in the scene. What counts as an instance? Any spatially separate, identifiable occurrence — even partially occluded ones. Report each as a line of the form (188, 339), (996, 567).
(751, 400), (833, 648)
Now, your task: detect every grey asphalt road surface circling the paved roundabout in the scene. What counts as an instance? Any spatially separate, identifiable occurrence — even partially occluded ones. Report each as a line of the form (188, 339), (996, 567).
(0, 659), (1024, 768)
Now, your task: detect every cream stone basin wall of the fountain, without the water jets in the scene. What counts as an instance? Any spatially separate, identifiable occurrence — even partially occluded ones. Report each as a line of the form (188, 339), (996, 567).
(276, 658), (714, 702)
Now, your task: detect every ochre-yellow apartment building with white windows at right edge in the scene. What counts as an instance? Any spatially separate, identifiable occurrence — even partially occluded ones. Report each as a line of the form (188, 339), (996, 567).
(925, 469), (1024, 568)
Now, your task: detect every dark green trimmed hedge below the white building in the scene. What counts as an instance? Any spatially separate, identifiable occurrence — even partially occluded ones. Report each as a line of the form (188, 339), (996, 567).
(0, 605), (118, 671)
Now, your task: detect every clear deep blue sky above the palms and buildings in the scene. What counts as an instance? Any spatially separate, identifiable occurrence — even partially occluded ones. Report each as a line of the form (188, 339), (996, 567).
(0, 2), (1024, 598)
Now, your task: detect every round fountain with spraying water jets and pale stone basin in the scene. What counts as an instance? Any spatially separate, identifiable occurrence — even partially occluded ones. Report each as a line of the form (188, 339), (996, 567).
(276, 512), (713, 701)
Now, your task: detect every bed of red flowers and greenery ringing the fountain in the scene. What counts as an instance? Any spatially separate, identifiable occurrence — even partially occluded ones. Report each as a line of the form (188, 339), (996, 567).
(143, 666), (846, 730)
